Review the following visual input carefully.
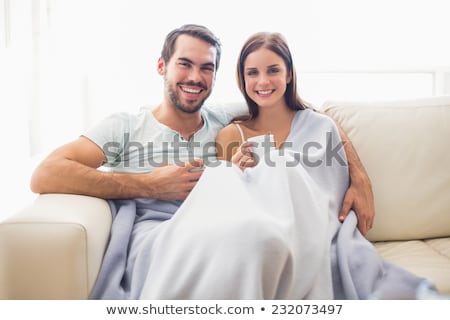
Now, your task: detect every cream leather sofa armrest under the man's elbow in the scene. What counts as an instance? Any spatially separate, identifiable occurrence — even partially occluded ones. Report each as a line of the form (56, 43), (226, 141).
(0, 194), (111, 299)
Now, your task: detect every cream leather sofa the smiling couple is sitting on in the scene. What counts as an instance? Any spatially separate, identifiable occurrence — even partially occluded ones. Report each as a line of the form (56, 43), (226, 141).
(0, 97), (450, 299)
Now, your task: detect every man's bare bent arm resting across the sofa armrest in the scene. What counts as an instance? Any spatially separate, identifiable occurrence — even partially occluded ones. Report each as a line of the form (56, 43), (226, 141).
(30, 137), (202, 200)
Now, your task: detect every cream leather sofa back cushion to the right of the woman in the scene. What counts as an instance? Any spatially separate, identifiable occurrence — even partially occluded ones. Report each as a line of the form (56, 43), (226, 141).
(323, 96), (450, 241)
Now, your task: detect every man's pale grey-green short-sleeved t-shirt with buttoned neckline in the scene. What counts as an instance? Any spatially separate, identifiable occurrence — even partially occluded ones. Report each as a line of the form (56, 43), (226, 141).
(84, 106), (243, 173)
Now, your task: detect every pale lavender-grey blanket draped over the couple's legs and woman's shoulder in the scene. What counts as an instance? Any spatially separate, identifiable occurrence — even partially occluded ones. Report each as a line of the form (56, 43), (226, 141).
(90, 110), (433, 300)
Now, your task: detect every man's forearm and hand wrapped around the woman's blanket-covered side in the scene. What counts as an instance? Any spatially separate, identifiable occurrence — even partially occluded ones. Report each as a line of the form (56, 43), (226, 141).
(336, 124), (375, 235)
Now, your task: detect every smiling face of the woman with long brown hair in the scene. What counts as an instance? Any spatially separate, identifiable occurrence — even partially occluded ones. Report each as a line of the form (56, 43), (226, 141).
(244, 48), (291, 108)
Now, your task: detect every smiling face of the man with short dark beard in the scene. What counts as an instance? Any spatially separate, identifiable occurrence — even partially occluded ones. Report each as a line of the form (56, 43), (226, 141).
(158, 35), (216, 113)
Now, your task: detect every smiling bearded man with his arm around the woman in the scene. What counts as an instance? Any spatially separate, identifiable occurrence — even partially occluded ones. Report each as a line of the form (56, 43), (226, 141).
(31, 25), (374, 234)
